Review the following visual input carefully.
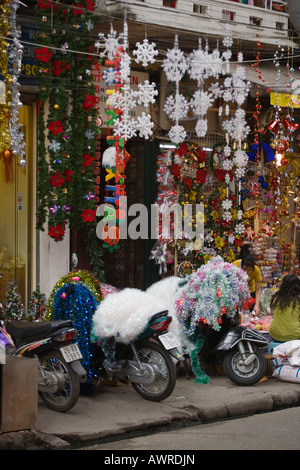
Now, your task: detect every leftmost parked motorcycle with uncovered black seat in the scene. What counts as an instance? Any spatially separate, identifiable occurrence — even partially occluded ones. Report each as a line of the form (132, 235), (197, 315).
(2, 320), (86, 412)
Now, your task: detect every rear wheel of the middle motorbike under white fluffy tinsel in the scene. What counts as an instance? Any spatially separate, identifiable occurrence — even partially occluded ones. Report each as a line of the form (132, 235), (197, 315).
(131, 341), (176, 401)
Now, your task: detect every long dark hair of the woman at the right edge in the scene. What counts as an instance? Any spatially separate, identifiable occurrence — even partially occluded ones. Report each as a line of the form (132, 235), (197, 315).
(270, 274), (300, 309)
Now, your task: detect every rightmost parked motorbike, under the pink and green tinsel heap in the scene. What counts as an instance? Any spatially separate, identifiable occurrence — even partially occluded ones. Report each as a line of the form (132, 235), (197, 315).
(200, 318), (268, 385)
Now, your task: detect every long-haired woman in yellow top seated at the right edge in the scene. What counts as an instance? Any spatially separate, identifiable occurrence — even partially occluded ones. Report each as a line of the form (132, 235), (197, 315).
(269, 274), (300, 343)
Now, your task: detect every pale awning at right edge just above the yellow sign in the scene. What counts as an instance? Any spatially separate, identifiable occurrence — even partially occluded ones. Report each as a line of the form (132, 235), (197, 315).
(244, 62), (300, 95)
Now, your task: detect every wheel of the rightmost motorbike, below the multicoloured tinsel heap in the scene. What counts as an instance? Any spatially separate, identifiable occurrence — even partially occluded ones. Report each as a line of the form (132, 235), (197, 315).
(223, 347), (267, 385)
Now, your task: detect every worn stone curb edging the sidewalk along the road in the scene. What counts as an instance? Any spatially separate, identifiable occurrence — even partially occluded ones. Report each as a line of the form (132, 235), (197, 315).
(0, 378), (300, 450)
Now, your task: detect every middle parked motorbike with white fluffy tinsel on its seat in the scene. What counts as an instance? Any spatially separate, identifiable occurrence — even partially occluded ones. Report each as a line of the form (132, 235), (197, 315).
(91, 311), (184, 402)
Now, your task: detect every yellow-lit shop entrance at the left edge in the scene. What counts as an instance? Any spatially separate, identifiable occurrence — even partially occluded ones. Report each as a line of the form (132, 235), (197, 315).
(0, 104), (35, 308)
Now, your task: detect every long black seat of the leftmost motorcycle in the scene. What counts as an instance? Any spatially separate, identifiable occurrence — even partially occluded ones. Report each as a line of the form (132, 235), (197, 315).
(6, 320), (73, 341)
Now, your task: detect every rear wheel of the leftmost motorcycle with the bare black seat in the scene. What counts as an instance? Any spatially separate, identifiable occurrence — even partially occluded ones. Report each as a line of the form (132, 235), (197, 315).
(39, 351), (80, 413)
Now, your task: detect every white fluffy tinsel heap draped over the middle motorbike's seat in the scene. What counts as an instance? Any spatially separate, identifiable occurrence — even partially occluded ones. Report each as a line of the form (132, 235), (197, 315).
(93, 288), (168, 344)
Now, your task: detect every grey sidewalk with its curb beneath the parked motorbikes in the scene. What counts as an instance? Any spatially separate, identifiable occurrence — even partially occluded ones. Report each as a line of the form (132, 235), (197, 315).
(0, 375), (300, 450)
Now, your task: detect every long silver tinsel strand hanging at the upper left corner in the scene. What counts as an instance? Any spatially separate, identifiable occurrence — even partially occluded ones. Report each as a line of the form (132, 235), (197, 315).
(8, 0), (26, 167)
